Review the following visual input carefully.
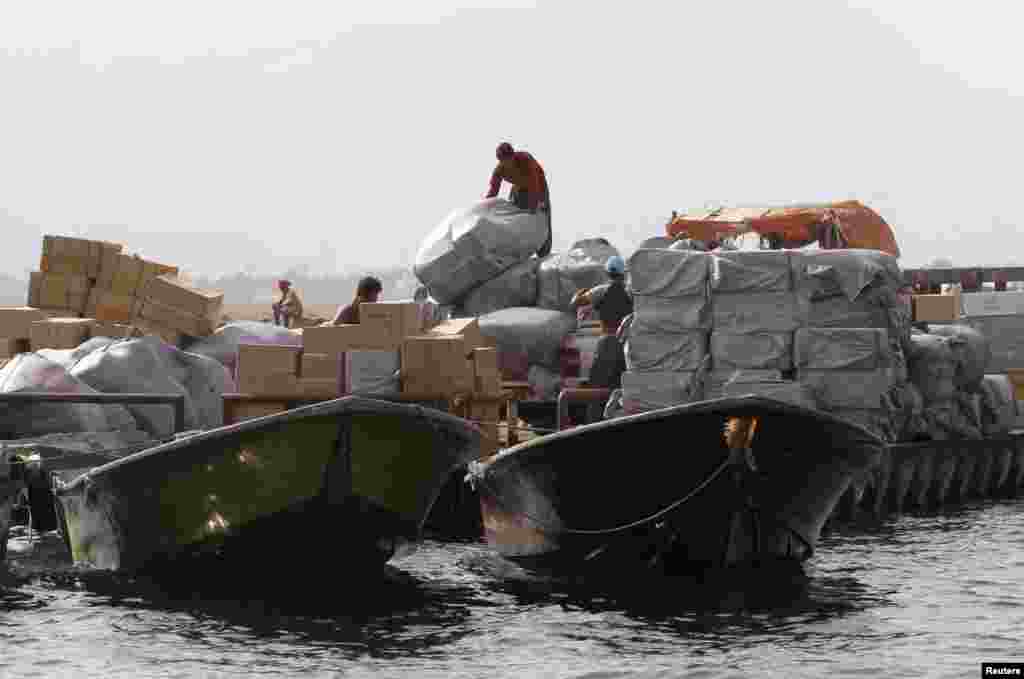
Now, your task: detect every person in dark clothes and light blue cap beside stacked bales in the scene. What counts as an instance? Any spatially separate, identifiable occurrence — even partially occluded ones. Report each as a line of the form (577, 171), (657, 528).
(572, 255), (633, 421)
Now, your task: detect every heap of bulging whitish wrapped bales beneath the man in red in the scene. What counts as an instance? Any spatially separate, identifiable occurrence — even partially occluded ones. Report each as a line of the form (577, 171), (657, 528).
(414, 198), (618, 398)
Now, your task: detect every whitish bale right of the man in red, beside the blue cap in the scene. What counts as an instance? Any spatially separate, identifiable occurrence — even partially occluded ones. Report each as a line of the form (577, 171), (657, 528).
(537, 238), (618, 311)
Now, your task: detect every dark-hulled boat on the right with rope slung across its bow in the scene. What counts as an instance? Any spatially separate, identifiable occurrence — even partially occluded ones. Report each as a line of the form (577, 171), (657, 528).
(467, 395), (885, 570)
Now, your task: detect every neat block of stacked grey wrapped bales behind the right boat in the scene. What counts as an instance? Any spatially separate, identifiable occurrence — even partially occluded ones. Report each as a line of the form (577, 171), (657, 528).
(622, 248), (909, 436)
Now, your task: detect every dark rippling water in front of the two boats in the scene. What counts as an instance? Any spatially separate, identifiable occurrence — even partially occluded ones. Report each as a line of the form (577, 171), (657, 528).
(0, 500), (1024, 679)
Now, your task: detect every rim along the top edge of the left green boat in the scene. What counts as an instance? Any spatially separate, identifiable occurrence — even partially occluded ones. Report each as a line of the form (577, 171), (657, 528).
(53, 396), (482, 496)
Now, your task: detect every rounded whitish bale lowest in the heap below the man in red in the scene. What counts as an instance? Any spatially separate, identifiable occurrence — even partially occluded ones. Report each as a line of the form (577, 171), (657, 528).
(477, 306), (577, 372)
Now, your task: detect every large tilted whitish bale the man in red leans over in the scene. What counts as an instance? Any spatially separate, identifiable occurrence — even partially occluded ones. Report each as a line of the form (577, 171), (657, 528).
(413, 198), (550, 304)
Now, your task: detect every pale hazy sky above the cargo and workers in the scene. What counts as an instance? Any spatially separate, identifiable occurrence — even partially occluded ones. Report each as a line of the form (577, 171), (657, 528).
(0, 0), (1024, 274)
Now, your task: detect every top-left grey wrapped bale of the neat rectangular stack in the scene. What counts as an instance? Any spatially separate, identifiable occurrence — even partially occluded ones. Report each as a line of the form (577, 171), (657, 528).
(628, 250), (712, 297)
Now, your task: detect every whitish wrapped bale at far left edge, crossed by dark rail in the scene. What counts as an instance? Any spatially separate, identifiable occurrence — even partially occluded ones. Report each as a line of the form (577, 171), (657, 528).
(0, 353), (137, 439)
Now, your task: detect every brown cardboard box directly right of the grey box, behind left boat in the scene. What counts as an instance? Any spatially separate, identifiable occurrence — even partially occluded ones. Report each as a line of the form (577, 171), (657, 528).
(401, 335), (473, 395)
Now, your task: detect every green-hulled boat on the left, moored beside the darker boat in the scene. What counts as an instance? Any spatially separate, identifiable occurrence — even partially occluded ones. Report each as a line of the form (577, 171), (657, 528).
(54, 396), (480, 572)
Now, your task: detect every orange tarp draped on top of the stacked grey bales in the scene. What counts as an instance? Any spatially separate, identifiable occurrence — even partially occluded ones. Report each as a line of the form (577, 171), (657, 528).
(666, 201), (900, 257)
